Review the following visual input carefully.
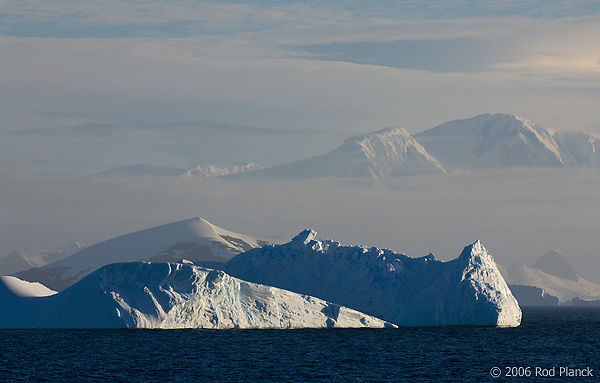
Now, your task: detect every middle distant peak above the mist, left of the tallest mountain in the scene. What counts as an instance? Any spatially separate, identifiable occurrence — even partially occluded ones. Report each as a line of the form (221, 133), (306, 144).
(251, 127), (445, 179)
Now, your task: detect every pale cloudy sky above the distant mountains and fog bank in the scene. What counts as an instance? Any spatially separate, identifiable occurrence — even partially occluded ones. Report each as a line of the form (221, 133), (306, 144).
(0, 0), (600, 176)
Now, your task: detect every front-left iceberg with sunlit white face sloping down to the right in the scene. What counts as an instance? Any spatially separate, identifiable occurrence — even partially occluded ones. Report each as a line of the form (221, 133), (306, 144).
(0, 262), (392, 329)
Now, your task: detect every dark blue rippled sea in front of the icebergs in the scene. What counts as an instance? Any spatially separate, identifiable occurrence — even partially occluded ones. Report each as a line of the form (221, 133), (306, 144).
(0, 307), (600, 383)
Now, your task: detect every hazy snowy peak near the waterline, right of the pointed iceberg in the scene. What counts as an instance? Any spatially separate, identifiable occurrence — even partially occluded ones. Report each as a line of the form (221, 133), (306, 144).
(499, 251), (600, 306)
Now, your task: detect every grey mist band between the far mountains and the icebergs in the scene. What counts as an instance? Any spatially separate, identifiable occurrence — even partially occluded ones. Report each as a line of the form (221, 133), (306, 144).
(0, 168), (600, 283)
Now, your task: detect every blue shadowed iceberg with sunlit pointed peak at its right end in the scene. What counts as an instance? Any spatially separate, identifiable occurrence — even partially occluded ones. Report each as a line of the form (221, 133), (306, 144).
(211, 230), (521, 326)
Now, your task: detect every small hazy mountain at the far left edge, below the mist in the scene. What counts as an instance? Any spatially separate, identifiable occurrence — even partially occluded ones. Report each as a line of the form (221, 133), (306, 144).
(0, 242), (86, 275)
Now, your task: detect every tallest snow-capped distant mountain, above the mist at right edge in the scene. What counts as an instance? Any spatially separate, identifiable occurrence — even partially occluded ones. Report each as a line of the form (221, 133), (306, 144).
(415, 114), (600, 170)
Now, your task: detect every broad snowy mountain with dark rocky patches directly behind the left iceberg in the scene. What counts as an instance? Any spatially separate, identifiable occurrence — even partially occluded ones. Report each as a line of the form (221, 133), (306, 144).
(16, 218), (280, 291)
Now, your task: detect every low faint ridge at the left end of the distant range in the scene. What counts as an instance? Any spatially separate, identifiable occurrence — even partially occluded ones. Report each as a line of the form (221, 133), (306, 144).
(92, 162), (263, 178)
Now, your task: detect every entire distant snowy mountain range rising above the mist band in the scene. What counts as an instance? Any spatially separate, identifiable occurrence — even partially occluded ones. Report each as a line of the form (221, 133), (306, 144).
(96, 114), (600, 179)
